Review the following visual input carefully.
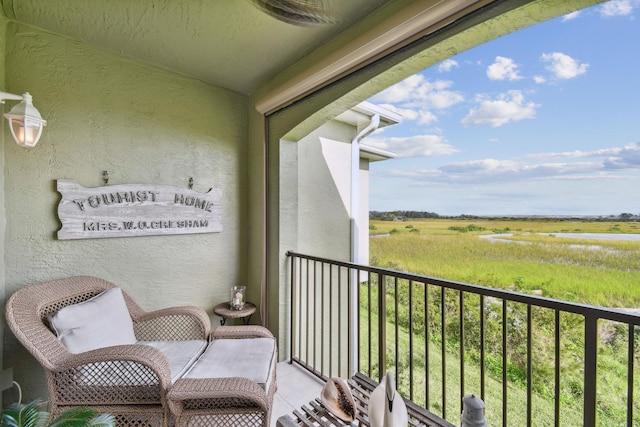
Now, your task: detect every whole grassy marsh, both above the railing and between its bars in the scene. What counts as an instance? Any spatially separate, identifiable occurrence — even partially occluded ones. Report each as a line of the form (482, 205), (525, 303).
(361, 220), (640, 426)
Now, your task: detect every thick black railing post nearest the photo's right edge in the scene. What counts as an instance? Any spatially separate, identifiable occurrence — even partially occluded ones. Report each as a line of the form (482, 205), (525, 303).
(583, 316), (598, 427)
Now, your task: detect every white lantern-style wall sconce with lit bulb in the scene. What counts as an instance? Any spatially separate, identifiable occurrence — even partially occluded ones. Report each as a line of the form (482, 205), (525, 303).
(0, 92), (47, 148)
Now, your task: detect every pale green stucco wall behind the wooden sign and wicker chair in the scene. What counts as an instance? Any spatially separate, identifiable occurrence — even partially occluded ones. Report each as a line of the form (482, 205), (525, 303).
(0, 23), (250, 401)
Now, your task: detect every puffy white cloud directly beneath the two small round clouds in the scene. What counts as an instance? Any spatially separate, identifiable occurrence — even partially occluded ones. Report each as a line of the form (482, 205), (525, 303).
(460, 90), (539, 127)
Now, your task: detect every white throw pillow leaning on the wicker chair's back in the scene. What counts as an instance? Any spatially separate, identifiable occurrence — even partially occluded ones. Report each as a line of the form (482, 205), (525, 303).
(49, 288), (136, 354)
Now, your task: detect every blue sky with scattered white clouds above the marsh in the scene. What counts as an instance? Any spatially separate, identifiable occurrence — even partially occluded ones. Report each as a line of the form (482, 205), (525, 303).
(363, 0), (640, 215)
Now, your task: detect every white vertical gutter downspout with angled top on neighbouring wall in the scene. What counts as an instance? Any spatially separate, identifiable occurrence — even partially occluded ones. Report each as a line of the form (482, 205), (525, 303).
(349, 113), (380, 376)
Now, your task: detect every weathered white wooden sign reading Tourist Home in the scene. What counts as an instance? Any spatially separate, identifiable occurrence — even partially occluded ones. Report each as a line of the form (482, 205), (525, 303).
(57, 179), (222, 240)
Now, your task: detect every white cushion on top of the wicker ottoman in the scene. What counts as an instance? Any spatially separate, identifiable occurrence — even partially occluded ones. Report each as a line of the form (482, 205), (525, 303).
(183, 338), (276, 391)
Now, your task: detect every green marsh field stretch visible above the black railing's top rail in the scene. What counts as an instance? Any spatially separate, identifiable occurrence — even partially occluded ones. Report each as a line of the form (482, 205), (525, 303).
(370, 219), (640, 307)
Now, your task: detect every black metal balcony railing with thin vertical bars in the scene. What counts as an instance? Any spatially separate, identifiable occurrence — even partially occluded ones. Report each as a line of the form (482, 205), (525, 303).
(287, 252), (640, 426)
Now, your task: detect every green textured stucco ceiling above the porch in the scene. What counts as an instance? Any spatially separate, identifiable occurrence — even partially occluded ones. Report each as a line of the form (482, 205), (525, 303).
(0, 0), (387, 94)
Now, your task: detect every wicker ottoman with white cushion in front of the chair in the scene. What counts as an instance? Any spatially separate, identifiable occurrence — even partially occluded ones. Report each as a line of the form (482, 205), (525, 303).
(168, 326), (277, 427)
